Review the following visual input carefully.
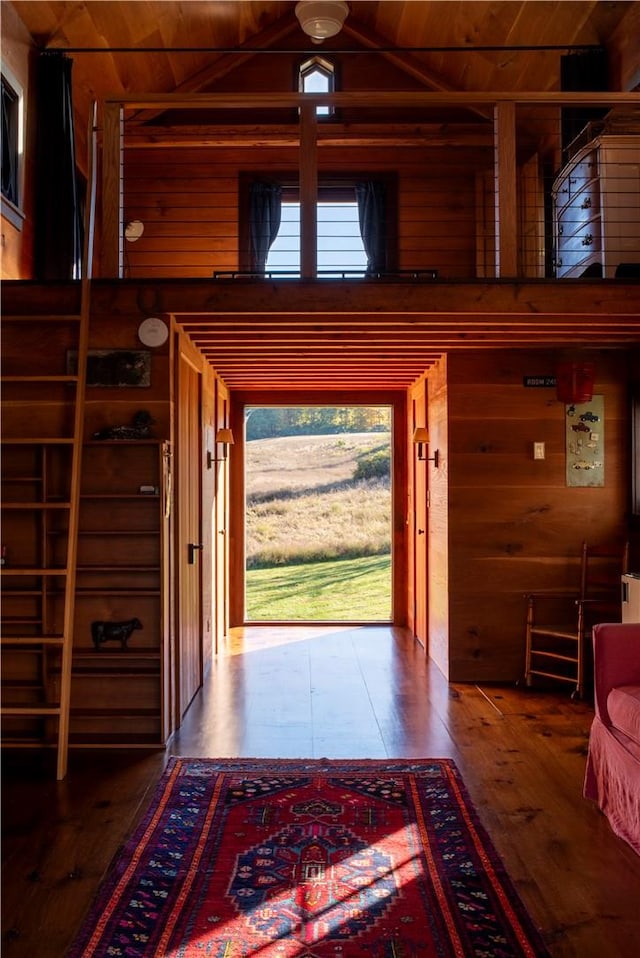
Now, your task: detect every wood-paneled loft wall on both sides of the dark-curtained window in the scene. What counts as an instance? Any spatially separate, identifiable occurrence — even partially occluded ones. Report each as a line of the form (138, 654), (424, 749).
(124, 147), (482, 279)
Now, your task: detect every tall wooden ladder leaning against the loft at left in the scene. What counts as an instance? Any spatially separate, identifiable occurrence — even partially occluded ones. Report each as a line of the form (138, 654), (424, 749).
(0, 107), (96, 779)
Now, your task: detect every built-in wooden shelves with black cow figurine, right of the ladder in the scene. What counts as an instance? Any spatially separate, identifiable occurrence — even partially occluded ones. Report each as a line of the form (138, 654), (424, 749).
(70, 439), (171, 748)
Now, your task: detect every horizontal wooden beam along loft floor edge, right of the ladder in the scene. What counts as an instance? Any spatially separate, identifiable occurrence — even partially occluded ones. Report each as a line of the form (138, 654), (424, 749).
(89, 279), (640, 320)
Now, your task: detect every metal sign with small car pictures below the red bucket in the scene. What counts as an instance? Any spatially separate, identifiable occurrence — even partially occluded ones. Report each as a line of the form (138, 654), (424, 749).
(565, 396), (604, 486)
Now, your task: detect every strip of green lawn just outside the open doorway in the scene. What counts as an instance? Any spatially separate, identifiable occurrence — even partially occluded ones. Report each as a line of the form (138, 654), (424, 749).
(246, 555), (391, 622)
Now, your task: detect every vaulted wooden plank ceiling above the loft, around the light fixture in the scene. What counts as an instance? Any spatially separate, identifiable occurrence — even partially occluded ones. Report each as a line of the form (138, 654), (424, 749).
(10, 0), (637, 109)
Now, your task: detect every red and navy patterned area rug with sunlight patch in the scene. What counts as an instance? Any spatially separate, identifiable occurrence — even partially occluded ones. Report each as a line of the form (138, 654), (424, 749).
(70, 758), (548, 958)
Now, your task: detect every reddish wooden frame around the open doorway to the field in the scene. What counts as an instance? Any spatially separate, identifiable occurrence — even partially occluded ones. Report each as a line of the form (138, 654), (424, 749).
(229, 390), (407, 627)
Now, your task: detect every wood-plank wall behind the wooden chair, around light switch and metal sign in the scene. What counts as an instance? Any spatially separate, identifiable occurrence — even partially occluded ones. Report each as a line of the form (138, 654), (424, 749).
(429, 350), (631, 681)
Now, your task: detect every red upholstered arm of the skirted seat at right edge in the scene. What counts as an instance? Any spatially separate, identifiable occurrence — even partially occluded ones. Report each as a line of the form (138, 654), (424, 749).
(593, 622), (640, 725)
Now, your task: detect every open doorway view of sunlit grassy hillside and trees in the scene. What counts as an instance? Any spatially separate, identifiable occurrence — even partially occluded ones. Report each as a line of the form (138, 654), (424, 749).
(244, 405), (393, 622)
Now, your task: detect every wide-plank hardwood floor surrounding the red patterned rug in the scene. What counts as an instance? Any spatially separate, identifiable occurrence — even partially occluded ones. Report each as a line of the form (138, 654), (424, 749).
(2, 626), (640, 958)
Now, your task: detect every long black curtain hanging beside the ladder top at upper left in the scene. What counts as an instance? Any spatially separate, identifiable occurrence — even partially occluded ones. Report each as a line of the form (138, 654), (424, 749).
(35, 52), (82, 280)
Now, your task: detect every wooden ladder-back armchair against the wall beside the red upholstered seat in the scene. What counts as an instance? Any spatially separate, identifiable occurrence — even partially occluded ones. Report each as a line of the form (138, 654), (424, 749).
(525, 542), (628, 698)
